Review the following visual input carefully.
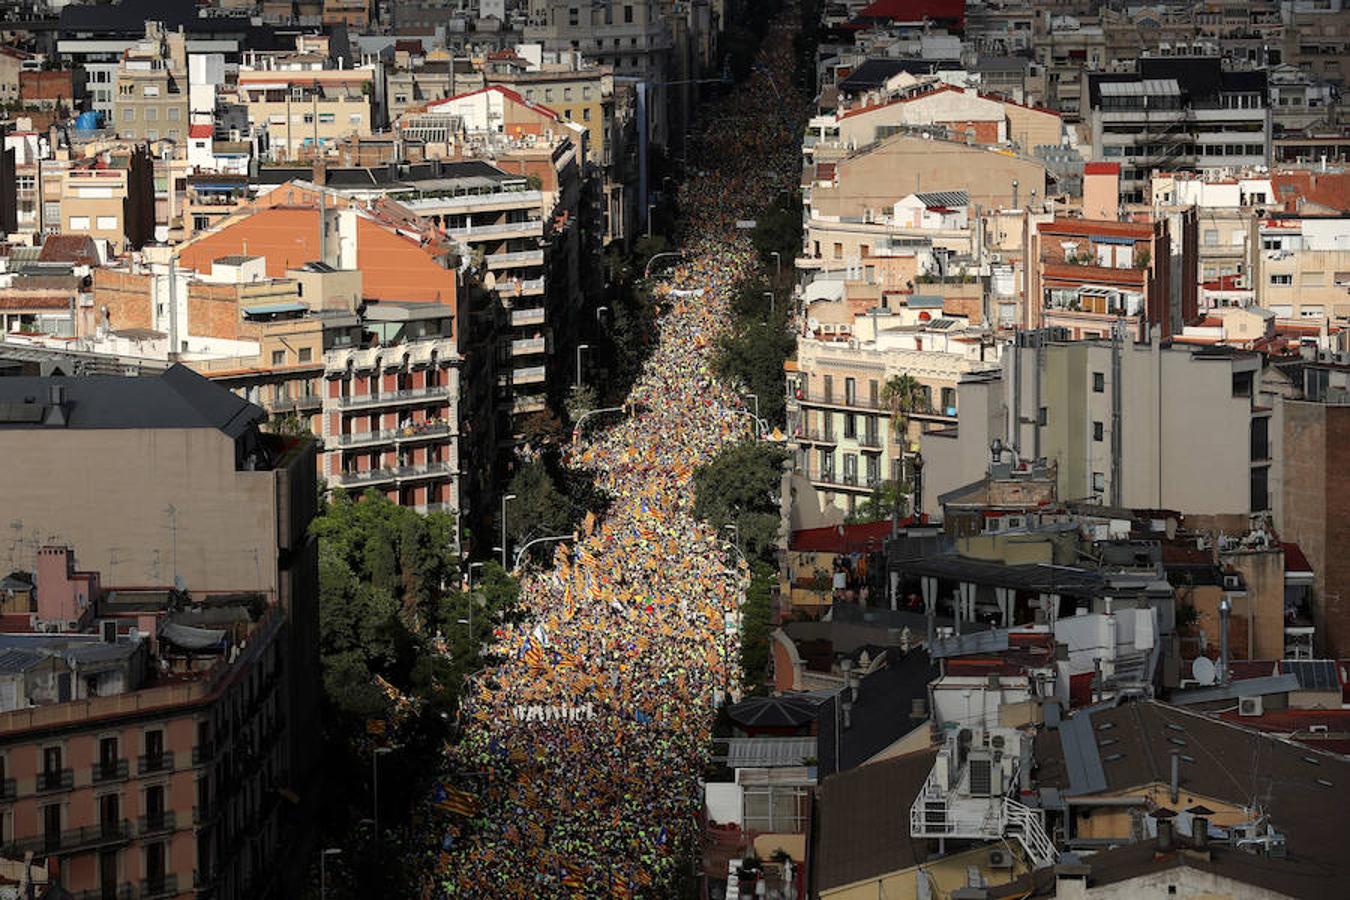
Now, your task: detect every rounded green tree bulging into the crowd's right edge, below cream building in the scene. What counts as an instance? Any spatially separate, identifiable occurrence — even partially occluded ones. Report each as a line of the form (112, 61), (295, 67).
(694, 441), (787, 559)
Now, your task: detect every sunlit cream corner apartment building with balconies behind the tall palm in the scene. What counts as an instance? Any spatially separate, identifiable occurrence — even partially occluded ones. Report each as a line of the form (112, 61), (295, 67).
(787, 296), (999, 513)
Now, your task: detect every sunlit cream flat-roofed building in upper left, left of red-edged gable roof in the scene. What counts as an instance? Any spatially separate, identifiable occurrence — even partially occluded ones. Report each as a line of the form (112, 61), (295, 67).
(238, 69), (375, 161)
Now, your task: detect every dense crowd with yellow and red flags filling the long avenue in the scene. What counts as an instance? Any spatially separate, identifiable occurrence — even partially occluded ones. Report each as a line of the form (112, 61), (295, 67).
(428, 8), (798, 899)
